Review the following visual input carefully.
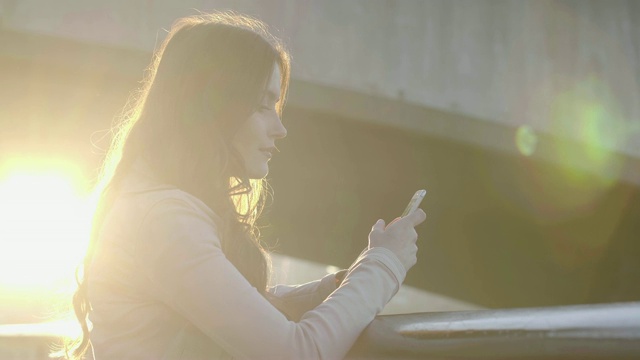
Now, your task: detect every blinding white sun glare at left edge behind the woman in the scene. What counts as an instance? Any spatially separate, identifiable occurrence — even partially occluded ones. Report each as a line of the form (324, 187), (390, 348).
(0, 159), (92, 290)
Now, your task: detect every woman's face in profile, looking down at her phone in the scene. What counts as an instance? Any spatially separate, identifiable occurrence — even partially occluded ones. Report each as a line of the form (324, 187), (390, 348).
(231, 64), (287, 179)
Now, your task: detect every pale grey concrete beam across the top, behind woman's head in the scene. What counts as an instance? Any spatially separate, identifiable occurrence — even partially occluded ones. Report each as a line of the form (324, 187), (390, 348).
(0, 0), (640, 156)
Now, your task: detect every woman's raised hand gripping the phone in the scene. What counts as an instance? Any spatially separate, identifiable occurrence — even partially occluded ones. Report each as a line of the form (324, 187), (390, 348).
(369, 209), (427, 271)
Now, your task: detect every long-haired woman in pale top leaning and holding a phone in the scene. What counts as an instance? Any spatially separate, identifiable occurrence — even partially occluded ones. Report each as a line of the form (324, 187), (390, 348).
(70, 13), (425, 360)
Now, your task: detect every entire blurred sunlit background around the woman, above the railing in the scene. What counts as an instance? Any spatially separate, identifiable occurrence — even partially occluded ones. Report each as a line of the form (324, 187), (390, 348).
(0, 0), (640, 348)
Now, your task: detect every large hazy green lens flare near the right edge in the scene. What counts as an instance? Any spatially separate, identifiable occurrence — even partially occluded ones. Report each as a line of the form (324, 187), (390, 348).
(498, 74), (636, 224)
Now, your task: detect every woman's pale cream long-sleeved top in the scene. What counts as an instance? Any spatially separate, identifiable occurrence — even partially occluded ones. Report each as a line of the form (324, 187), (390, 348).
(88, 165), (406, 360)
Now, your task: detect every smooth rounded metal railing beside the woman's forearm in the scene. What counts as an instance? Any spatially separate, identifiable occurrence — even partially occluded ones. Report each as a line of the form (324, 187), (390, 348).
(348, 302), (640, 359)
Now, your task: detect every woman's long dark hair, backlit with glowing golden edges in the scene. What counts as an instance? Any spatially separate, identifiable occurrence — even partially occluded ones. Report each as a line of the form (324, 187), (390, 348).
(63, 12), (290, 358)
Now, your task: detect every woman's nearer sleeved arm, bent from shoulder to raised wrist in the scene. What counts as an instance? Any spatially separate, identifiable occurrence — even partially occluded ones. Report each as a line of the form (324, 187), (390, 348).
(136, 199), (406, 359)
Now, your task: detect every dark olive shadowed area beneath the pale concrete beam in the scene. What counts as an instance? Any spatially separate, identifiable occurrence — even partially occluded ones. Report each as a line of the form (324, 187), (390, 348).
(263, 108), (640, 307)
